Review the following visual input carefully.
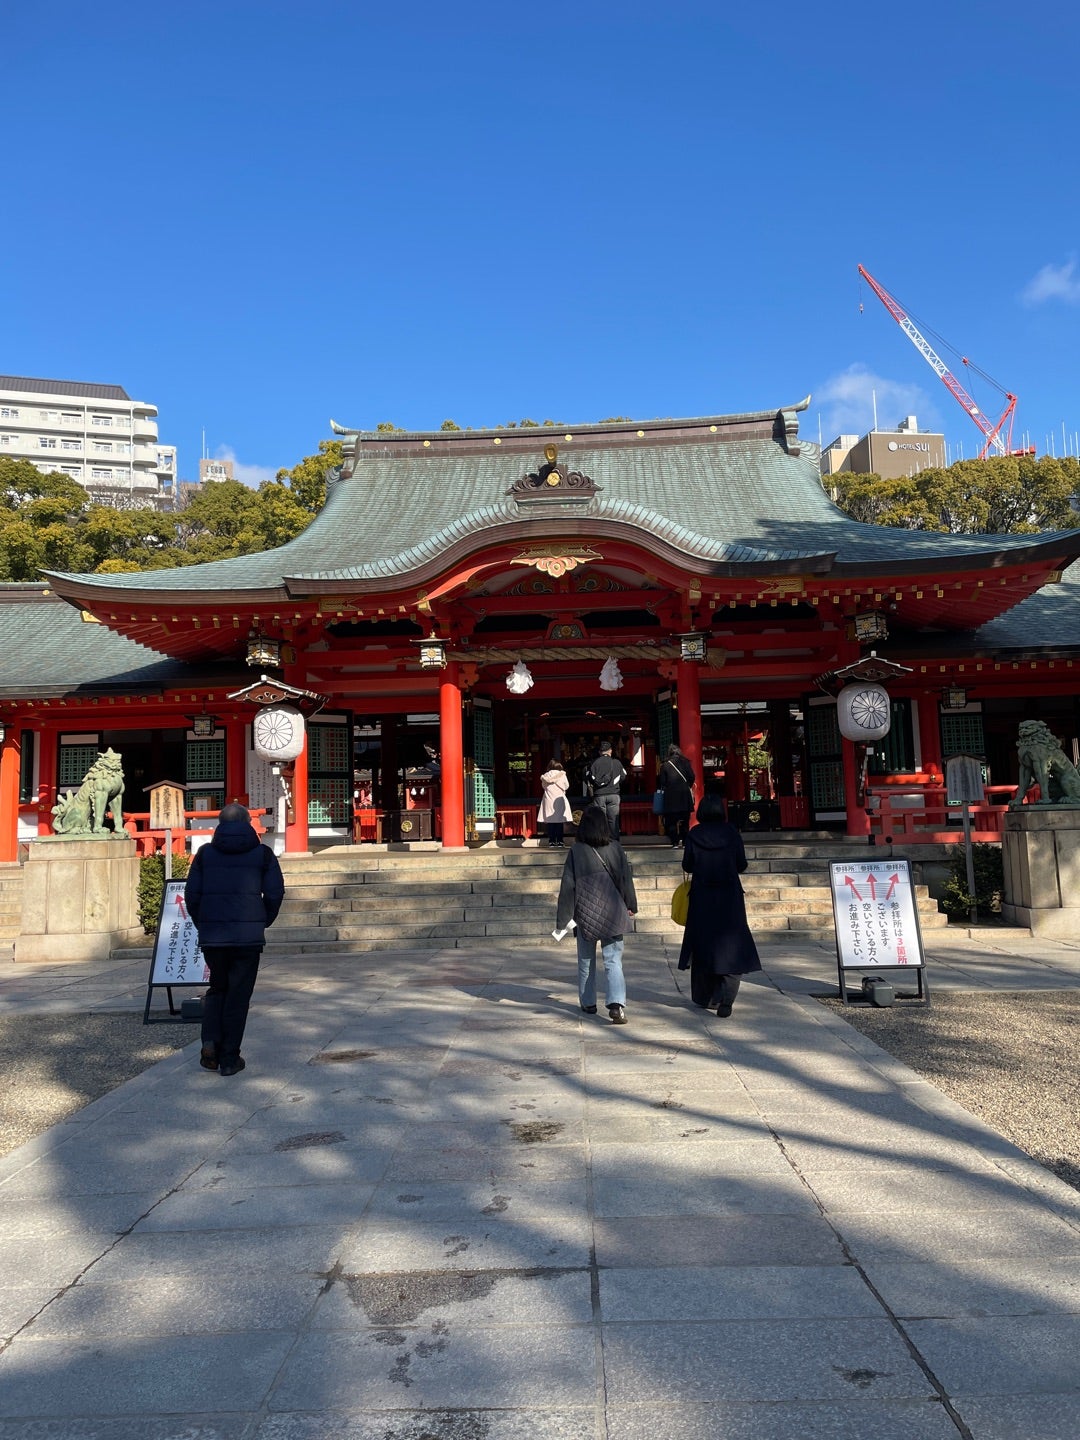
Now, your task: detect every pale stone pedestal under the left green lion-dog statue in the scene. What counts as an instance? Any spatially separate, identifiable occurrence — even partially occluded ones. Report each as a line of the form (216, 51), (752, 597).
(14, 835), (145, 960)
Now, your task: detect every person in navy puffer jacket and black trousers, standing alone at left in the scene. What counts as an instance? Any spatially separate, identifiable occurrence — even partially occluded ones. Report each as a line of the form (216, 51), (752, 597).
(184, 805), (285, 1076)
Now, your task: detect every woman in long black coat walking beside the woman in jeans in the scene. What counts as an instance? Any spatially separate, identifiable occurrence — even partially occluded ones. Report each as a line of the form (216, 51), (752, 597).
(678, 795), (762, 1015)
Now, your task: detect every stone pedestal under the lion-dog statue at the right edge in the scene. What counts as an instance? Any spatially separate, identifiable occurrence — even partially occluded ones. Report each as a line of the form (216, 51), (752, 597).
(1001, 804), (1080, 940)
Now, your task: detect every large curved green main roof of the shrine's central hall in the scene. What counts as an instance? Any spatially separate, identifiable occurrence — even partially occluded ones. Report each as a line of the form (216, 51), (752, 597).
(44, 416), (1080, 595)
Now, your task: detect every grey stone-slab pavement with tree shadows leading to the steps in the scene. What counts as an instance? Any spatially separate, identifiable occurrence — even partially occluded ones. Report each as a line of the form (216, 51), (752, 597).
(0, 930), (1080, 1440)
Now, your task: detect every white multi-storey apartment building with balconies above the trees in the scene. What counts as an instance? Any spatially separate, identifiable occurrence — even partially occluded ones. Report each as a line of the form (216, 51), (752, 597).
(0, 374), (164, 508)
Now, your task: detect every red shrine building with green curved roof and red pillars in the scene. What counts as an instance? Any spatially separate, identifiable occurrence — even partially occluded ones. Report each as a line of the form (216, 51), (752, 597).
(0, 400), (1080, 861)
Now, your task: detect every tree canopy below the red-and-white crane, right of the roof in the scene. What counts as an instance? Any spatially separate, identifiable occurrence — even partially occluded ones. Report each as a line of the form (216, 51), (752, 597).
(824, 455), (1080, 534)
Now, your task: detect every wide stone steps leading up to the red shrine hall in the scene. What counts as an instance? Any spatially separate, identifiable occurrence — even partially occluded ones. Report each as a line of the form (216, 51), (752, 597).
(266, 842), (948, 956)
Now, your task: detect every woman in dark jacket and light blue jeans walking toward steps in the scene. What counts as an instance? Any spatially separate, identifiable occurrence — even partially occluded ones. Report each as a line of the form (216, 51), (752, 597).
(556, 805), (638, 1025)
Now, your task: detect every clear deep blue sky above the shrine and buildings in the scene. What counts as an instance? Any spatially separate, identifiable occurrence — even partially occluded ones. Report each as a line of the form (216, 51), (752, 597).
(0, 0), (1080, 482)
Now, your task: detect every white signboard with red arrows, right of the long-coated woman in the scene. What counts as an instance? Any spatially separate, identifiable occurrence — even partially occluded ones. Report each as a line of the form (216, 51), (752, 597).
(829, 860), (926, 1004)
